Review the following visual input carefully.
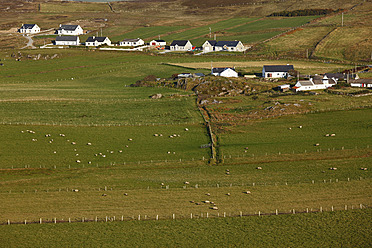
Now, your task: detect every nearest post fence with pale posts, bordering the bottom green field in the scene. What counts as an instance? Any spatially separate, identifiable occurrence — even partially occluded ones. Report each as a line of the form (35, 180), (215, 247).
(0, 204), (370, 225)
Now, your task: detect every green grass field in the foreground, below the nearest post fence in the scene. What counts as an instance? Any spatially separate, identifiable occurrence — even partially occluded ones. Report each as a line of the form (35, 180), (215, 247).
(0, 209), (371, 247)
